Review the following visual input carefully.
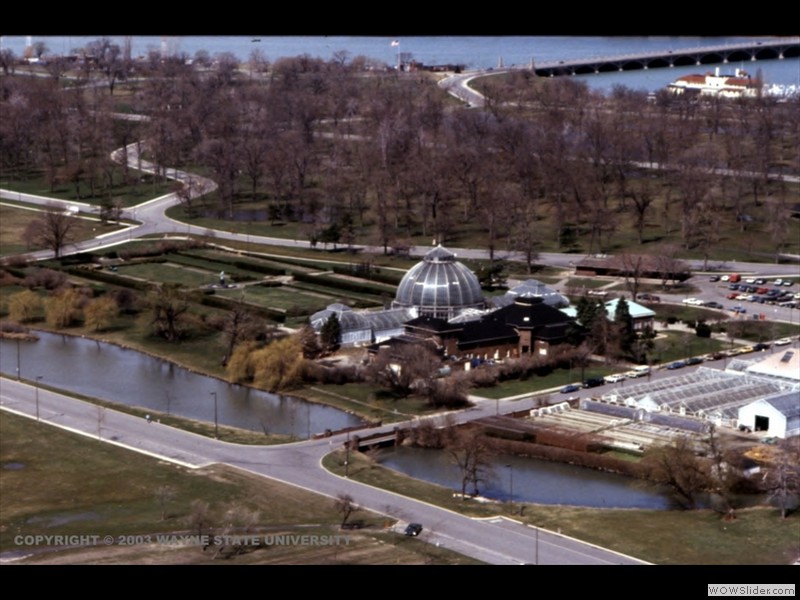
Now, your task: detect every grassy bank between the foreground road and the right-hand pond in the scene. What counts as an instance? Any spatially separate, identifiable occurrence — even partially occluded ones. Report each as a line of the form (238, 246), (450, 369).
(323, 451), (800, 565)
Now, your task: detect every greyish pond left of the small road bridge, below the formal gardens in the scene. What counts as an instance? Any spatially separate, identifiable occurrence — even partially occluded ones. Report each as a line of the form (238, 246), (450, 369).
(0, 332), (362, 438)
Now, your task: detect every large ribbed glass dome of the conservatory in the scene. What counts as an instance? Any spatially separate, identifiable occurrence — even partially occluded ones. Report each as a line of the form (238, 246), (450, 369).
(392, 246), (486, 319)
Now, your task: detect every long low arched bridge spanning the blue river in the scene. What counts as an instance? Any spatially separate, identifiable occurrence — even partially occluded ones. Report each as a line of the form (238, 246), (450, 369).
(524, 37), (800, 77)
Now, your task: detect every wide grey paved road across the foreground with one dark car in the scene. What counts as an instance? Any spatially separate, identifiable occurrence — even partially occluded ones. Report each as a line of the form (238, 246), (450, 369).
(0, 378), (644, 565)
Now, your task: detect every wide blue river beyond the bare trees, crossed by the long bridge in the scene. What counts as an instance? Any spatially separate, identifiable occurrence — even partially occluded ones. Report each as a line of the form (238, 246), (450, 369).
(0, 35), (800, 92)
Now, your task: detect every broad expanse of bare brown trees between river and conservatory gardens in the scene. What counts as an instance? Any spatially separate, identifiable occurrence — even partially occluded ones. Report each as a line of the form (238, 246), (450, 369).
(6, 44), (798, 268)
